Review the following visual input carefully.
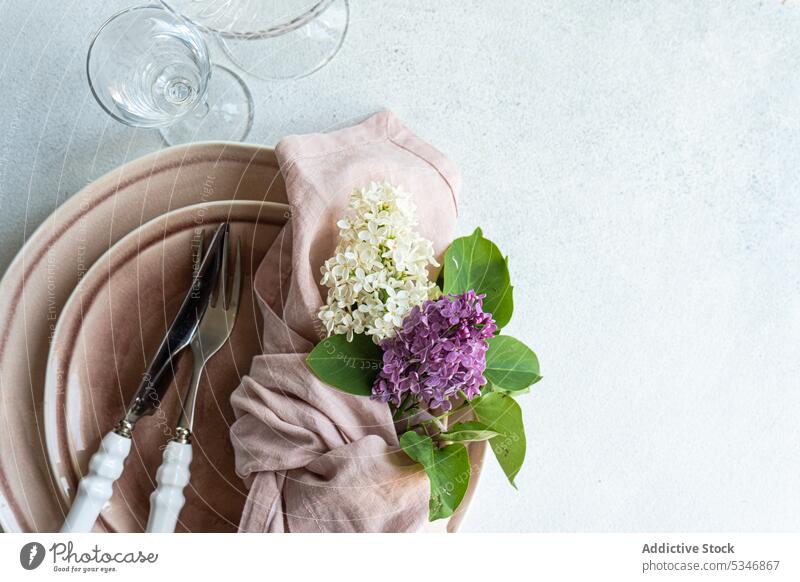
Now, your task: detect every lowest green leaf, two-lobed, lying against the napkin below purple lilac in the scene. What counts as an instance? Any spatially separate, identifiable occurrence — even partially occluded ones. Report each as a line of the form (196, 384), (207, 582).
(400, 431), (471, 521)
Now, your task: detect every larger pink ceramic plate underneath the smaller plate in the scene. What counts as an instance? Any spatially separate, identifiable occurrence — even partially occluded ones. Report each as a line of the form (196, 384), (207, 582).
(0, 143), (286, 532)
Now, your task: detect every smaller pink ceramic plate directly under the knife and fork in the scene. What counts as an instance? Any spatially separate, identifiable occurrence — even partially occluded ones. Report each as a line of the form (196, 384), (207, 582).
(44, 201), (289, 532)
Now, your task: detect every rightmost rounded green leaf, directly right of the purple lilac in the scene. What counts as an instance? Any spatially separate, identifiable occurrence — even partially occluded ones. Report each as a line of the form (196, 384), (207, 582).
(484, 335), (542, 392)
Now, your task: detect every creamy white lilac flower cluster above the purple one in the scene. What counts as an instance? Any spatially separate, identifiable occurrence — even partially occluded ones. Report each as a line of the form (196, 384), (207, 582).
(319, 182), (439, 343)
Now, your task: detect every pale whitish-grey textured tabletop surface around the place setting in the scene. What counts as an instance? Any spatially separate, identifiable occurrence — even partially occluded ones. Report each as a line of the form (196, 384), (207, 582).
(0, 0), (800, 531)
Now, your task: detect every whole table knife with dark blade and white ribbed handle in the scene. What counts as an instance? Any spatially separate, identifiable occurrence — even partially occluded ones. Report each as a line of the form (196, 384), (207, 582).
(61, 224), (228, 533)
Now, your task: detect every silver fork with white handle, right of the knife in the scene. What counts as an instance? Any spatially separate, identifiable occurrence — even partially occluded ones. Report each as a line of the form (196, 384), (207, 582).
(147, 230), (242, 533)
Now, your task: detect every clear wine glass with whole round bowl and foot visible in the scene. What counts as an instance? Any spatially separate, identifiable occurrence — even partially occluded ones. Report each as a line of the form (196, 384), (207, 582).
(86, 4), (253, 145)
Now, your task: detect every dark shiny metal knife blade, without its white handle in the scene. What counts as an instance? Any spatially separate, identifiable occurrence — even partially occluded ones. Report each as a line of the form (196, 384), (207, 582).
(115, 223), (229, 437)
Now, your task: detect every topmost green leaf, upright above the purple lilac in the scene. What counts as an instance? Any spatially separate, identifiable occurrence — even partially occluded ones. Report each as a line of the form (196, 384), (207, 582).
(442, 228), (514, 328)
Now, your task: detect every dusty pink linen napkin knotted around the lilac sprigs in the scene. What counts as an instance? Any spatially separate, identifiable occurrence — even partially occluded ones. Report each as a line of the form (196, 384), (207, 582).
(231, 111), (460, 532)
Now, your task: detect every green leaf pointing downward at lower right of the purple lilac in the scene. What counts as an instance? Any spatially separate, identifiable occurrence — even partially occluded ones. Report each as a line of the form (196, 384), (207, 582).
(472, 392), (525, 487)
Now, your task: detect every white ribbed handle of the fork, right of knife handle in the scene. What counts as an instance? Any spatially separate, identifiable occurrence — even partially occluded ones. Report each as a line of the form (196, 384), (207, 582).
(147, 441), (192, 533)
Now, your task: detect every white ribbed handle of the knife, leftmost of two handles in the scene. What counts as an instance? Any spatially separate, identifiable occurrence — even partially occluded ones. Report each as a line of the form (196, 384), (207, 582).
(61, 431), (131, 533)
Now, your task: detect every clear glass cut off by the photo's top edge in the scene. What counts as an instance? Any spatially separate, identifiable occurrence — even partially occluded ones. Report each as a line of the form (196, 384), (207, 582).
(161, 0), (350, 80)
